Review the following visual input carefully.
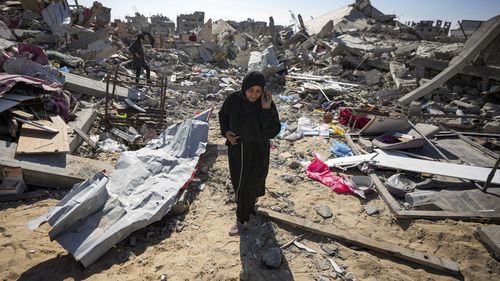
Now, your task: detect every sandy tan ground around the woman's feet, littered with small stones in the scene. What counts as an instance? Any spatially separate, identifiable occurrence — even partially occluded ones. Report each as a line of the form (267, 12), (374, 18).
(0, 118), (500, 281)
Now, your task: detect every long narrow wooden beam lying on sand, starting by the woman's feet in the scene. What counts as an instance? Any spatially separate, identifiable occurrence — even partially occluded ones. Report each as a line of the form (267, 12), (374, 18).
(257, 209), (459, 273)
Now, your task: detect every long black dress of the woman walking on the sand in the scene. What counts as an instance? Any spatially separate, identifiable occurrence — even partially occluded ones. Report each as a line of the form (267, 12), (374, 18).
(219, 91), (281, 223)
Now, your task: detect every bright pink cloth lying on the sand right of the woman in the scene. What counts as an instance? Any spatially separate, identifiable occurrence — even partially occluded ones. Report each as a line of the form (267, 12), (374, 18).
(306, 158), (355, 194)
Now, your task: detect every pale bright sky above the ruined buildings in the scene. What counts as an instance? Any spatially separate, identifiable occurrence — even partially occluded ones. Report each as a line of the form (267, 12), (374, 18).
(78, 0), (500, 25)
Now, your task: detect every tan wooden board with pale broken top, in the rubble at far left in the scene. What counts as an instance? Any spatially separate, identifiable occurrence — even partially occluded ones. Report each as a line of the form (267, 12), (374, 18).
(16, 116), (69, 154)
